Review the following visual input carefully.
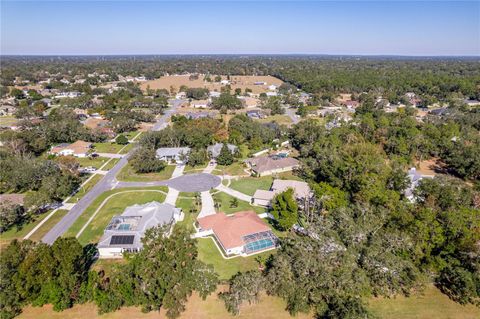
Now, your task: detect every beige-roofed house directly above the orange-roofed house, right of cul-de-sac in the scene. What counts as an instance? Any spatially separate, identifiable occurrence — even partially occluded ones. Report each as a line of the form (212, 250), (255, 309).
(252, 179), (311, 206)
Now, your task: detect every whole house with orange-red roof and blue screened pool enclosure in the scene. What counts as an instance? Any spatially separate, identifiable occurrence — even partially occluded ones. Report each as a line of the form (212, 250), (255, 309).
(195, 211), (278, 256)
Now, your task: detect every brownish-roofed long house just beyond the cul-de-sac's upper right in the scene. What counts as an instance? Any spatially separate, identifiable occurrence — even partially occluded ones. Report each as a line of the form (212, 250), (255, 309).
(246, 156), (300, 176)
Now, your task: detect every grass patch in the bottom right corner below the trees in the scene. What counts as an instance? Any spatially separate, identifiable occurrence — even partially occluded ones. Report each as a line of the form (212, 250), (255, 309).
(368, 286), (480, 319)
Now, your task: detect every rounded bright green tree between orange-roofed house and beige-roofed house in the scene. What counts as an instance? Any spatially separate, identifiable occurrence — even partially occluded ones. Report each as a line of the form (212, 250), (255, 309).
(272, 188), (298, 230)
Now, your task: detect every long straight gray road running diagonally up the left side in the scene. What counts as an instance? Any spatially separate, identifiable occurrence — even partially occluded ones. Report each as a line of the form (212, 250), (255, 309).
(42, 100), (182, 245)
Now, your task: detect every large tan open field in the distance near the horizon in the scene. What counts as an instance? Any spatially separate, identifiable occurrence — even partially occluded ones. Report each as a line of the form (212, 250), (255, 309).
(140, 75), (283, 94)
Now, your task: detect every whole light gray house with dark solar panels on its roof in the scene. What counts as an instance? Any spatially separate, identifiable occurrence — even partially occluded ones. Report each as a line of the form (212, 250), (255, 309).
(97, 202), (184, 258)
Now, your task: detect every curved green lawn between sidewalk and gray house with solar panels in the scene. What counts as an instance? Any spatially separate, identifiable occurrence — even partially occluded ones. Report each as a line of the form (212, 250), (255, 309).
(78, 190), (165, 245)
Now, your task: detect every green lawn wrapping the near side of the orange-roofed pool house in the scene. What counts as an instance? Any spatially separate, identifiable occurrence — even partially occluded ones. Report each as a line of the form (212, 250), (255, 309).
(197, 238), (272, 279)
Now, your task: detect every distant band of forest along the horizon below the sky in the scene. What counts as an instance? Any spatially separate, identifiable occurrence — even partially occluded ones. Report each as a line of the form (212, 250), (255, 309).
(2, 56), (480, 101)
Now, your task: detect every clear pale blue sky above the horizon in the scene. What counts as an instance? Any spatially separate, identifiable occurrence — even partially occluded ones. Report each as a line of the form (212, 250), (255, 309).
(0, 0), (480, 56)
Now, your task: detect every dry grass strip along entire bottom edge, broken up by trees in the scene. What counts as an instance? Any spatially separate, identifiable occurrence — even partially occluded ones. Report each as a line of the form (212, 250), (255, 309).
(17, 287), (480, 319)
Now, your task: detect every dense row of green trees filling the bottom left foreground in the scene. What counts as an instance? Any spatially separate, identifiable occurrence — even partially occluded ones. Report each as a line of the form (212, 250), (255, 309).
(0, 227), (218, 319)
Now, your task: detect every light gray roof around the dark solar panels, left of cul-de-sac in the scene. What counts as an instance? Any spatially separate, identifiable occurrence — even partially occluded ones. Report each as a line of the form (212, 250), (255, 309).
(98, 202), (181, 248)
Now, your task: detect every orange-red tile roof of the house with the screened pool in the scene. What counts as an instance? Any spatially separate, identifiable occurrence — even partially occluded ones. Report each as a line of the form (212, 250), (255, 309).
(198, 211), (270, 249)
